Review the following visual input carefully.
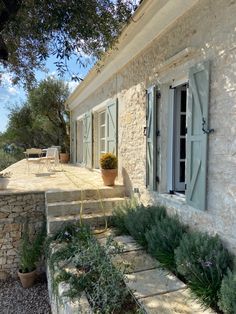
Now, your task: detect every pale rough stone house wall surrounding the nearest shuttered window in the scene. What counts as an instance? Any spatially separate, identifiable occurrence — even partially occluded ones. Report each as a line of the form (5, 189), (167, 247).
(72, 0), (236, 253)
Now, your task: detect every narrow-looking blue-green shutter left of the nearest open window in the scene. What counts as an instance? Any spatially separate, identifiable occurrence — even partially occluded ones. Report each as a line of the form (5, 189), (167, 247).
(146, 86), (157, 190)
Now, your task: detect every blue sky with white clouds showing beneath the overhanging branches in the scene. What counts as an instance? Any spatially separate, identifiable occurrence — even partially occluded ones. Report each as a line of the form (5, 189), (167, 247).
(0, 56), (92, 132)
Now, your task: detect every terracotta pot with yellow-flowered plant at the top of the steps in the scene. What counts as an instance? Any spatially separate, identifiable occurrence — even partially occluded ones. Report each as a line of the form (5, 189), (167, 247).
(100, 153), (117, 186)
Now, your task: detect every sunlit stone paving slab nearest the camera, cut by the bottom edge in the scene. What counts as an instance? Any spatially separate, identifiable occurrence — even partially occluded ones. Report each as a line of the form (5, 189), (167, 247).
(139, 289), (214, 314)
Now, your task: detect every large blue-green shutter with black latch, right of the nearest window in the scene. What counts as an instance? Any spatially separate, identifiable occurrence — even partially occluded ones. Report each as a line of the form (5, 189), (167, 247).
(186, 62), (209, 210)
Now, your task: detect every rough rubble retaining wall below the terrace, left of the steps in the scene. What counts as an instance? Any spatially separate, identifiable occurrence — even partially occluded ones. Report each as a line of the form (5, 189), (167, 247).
(0, 192), (45, 276)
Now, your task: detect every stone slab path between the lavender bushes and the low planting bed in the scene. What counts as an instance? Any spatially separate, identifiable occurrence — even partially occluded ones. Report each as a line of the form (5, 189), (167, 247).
(97, 230), (214, 314)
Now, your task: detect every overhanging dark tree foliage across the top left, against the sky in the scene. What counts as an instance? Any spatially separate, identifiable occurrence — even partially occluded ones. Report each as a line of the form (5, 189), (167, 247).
(0, 0), (134, 84)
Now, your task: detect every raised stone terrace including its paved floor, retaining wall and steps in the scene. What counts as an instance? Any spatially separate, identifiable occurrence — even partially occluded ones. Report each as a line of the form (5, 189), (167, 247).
(0, 160), (125, 279)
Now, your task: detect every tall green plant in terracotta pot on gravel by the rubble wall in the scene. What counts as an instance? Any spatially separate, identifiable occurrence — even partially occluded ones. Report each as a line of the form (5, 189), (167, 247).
(18, 221), (45, 288)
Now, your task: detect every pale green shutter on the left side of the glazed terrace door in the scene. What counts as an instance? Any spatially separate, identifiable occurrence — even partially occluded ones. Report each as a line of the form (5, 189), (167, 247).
(83, 112), (92, 168)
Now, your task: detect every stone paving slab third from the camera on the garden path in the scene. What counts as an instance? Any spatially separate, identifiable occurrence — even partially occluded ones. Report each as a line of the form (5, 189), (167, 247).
(111, 250), (159, 273)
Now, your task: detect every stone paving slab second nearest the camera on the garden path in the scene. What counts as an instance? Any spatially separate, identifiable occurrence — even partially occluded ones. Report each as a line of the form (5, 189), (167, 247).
(126, 268), (186, 299)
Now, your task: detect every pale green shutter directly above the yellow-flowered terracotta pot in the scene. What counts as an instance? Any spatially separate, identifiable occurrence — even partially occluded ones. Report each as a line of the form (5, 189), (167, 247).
(106, 101), (118, 155)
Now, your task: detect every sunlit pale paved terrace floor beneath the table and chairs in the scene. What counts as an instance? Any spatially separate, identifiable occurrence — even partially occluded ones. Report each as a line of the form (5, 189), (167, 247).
(0, 159), (122, 195)
